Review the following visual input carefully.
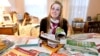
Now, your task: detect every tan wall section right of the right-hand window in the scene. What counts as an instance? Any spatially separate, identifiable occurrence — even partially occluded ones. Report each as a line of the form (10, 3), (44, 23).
(87, 0), (100, 17)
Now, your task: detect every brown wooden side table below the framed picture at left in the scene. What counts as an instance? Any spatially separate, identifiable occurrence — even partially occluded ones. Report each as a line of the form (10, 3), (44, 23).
(0, 25), (18, 35)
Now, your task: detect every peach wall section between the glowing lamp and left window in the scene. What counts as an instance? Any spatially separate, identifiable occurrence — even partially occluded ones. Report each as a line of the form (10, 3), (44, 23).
(6, 0), (24, 14)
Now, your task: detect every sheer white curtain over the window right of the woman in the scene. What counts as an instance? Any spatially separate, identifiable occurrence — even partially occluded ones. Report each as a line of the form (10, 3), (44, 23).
(69, 0), (89, 24)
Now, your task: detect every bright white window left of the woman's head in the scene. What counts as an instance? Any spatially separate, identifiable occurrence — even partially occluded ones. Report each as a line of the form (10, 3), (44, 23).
(25, 0), (47, 19)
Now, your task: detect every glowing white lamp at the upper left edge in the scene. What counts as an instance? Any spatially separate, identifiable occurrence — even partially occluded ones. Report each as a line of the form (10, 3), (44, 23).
(0, 0), (11, 23)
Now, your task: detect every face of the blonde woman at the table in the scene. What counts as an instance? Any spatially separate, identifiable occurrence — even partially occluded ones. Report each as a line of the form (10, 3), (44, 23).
(50, 4), (61, 19)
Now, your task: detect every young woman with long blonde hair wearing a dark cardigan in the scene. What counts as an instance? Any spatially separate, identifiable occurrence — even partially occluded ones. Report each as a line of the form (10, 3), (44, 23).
(40, 1), (68, 39)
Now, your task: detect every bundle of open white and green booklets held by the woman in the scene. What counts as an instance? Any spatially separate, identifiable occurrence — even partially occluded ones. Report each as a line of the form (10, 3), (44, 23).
(41, 27), (66, 48)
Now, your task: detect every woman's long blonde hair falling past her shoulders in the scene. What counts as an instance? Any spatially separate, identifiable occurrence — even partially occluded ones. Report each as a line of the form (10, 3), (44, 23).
(47, 1), (63, 32)
